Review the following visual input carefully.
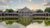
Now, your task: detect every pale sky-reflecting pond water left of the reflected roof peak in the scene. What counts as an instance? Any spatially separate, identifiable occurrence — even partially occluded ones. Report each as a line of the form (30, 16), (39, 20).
(0, 22), (25, 28)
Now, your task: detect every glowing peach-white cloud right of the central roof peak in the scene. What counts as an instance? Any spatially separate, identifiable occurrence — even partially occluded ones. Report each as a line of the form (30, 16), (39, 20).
(27, 2), (46, 10)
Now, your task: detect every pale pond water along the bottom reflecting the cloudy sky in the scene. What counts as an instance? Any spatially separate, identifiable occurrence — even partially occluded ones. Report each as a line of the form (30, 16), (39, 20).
(0, 21), (50, 28)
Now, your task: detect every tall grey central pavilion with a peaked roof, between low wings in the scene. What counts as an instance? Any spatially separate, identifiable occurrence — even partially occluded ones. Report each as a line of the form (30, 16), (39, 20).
(18, 7), (33, 16)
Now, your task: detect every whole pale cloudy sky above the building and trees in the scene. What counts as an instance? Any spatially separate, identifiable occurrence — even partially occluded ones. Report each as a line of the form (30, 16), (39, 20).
(0, 0), (50, 10)
